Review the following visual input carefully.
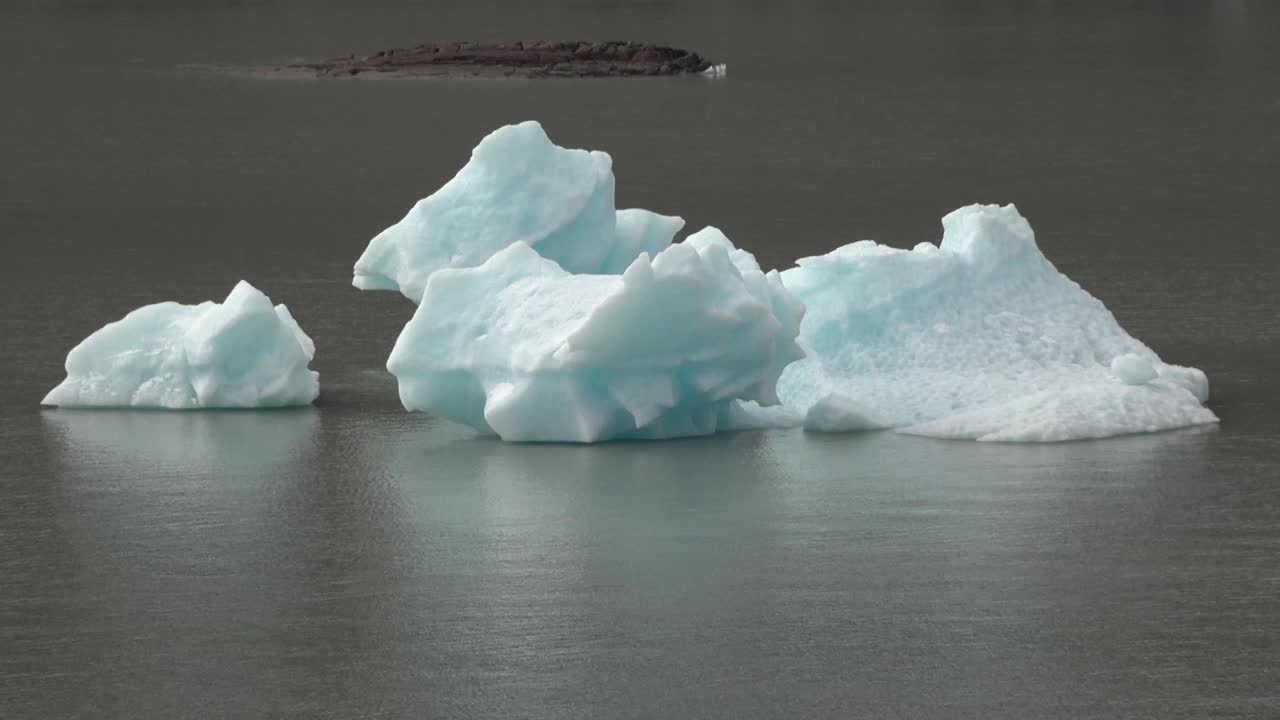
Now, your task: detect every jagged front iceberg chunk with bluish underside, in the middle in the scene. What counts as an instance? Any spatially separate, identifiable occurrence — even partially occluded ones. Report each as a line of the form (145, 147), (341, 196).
(387, 228), (804, 442)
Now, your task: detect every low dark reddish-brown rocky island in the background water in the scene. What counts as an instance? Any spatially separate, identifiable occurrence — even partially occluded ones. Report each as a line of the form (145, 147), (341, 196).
(285, 41), (722, 78)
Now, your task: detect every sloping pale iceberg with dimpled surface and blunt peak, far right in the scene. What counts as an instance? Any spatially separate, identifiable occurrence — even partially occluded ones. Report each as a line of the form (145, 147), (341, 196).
(769, 199), (1217, 442)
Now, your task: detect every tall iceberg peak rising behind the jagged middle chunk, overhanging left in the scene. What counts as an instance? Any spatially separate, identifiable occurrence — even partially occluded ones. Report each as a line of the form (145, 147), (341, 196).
(352, 120), (685, 302)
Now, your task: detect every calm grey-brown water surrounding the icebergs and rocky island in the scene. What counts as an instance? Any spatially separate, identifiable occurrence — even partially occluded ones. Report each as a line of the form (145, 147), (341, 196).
(0, 0), (1280, 719)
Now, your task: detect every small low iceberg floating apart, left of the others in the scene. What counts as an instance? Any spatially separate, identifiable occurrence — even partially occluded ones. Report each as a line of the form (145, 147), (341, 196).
(44, 281), (320, 410)
